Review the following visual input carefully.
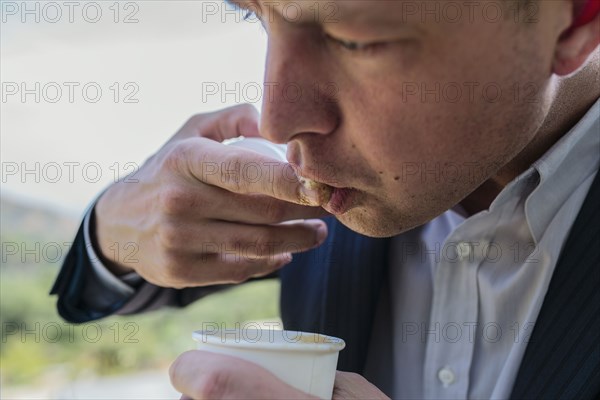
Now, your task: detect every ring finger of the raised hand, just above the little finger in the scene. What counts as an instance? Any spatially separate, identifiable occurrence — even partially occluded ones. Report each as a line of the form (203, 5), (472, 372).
(169, 220), (327, 260)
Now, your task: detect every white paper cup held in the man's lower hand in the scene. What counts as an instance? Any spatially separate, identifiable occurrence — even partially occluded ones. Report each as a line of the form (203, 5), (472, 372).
(192, 329), (346, 399)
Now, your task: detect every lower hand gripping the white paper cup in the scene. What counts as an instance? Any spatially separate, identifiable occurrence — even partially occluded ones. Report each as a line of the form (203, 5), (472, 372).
(169, 350), (389, 399)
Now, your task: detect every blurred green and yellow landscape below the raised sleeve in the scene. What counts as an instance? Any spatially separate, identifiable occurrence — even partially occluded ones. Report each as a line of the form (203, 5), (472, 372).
(0, 198), (279, 398)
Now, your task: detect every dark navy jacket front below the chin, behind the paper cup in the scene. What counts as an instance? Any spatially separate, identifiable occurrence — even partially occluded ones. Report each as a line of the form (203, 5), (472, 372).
(280, 218), (390, 372)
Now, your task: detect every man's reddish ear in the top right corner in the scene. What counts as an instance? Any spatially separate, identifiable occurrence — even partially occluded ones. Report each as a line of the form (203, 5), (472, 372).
(552, 0), (600, 76)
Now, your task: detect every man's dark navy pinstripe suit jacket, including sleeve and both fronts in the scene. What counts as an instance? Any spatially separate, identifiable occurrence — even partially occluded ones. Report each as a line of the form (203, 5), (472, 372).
(52, 174), (600, 399)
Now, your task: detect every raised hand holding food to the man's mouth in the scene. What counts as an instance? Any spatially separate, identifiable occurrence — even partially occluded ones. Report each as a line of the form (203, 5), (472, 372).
(95, 105), (327, 288)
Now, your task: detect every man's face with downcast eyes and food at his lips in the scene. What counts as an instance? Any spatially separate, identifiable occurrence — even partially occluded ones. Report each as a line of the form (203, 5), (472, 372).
(240, 0), (565, 236)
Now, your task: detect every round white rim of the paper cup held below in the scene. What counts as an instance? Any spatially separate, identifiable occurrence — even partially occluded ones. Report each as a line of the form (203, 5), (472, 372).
(192, 329), (346, 353)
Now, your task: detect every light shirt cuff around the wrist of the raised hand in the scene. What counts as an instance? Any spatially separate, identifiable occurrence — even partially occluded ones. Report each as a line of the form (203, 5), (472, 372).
(83, 203), (137, 298)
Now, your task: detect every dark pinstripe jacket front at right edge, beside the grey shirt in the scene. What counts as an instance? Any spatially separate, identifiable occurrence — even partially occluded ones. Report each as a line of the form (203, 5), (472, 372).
(511, 174), (600, 399)
